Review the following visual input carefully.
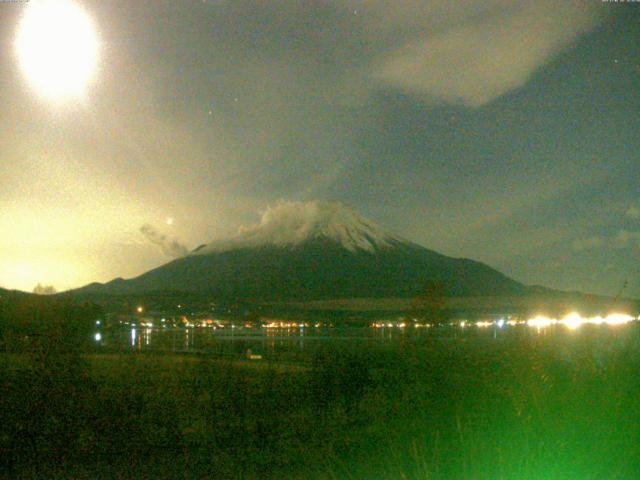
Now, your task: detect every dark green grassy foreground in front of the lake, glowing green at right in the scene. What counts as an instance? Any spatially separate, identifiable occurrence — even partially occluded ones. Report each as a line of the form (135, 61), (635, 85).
(0, 298), (640, 480)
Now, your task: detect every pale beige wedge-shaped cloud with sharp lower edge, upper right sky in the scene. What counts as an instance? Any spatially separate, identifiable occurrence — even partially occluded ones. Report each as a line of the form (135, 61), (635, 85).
(373, 0), (601, 107)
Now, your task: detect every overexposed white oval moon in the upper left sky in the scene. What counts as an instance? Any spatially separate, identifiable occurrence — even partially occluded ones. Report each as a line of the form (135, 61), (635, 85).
(16, 0), (98, 100)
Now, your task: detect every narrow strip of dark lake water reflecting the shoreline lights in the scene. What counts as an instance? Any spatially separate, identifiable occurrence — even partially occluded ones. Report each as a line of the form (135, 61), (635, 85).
(96, 321), (640, 359)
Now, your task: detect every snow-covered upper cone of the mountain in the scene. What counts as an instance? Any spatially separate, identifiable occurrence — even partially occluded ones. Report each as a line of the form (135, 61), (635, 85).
(192, 200), (403, 255)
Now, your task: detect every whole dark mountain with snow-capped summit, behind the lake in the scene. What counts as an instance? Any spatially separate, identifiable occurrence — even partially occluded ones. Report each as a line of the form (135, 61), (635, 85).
(75, 201), (526, 300)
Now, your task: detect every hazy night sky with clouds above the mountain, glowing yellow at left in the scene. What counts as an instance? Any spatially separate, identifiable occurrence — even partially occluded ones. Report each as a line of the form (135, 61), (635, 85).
(0, 0), (640, 296)
